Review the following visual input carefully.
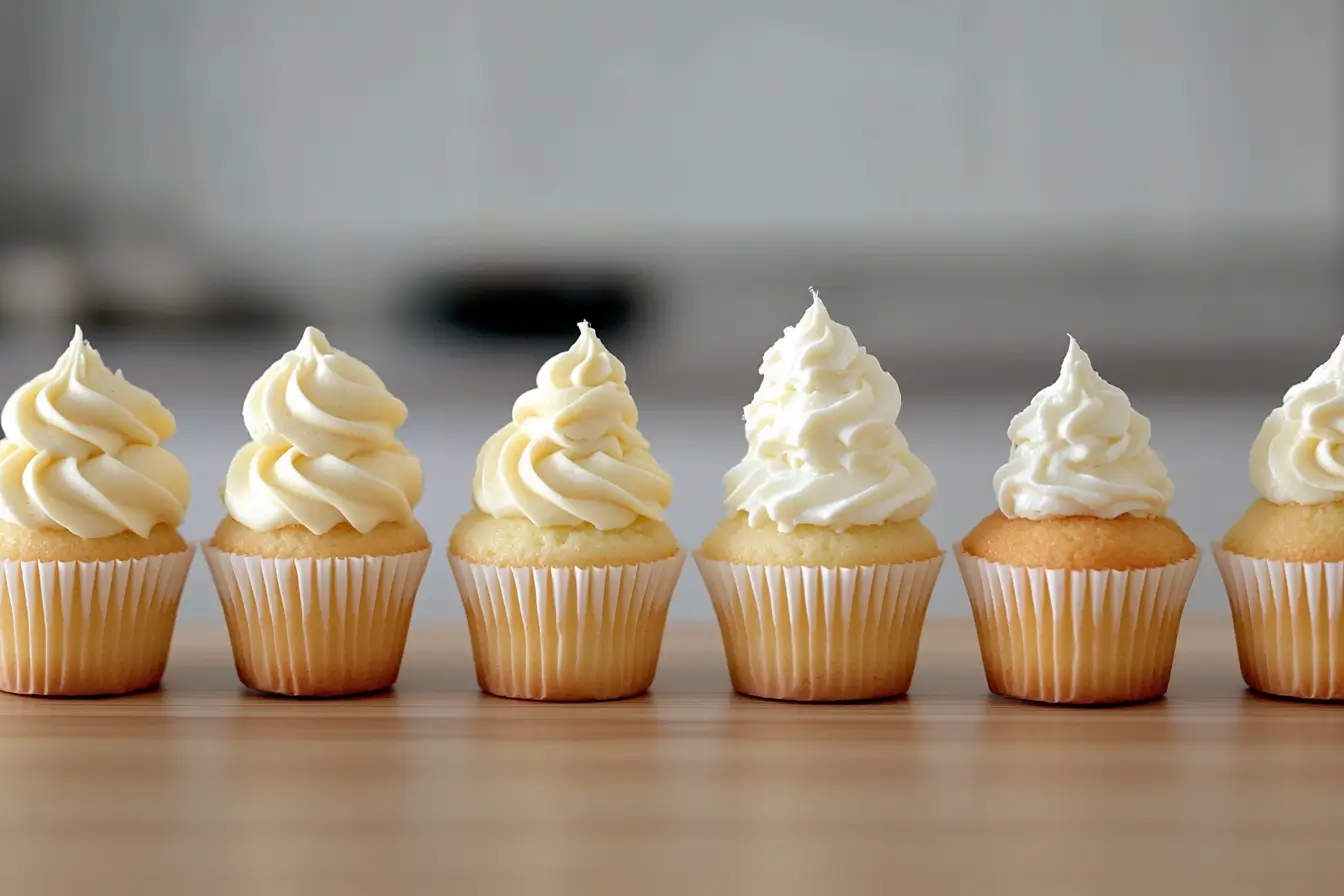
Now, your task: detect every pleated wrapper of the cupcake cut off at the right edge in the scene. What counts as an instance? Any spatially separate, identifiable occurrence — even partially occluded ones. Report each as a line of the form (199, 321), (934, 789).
(1214, 544), (1344, 700)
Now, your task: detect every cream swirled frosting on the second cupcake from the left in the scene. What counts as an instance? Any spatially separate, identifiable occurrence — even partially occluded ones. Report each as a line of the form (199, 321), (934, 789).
(223, 326), (425, 535)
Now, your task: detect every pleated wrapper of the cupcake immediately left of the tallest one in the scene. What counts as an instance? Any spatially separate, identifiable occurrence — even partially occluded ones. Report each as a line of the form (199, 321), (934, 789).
(449, 552), (685, 700)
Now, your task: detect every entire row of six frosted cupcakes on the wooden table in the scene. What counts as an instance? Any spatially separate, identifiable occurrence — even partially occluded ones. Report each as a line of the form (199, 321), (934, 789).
(0, 293), (1344, 704)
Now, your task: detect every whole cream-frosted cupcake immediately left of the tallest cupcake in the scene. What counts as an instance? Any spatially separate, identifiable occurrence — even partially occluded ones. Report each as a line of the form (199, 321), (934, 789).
(449, 322), (684, 700)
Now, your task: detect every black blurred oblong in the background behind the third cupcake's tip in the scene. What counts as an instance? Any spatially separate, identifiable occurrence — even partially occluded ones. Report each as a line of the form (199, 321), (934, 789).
(410, 266), (649, 340)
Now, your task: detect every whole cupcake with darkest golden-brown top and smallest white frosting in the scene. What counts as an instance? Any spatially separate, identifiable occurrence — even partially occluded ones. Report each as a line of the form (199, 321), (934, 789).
(957, 337), (1199, 704)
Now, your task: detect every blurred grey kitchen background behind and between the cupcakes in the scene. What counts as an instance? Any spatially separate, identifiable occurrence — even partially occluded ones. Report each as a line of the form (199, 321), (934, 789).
(0, 0), (1344, 619)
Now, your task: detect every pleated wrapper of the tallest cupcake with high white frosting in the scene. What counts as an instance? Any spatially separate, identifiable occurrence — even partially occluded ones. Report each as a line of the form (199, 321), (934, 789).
(695, 555), (942, 701)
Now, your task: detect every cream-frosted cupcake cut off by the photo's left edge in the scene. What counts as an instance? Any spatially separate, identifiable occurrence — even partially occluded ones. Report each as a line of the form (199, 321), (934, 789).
(0, 328), (192, 697)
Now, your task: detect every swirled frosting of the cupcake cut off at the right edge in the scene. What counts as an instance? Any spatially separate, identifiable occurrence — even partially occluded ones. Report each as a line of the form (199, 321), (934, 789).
(1250, 340), (1344, 504)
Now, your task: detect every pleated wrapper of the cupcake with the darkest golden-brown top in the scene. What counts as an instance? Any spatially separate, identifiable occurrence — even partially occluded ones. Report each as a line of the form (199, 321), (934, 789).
(957, 547), (1199, 704)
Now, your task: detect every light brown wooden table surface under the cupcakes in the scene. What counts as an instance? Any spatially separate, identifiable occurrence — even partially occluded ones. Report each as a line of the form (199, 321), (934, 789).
(0, 619), (1344, 896)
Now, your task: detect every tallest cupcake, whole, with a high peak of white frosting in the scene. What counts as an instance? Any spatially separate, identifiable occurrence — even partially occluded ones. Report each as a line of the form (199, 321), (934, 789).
(696, 290), (942, 701)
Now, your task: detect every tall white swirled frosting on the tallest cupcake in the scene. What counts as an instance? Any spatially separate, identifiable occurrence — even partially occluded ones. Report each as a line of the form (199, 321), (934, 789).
(724, 290), (935, 532)
